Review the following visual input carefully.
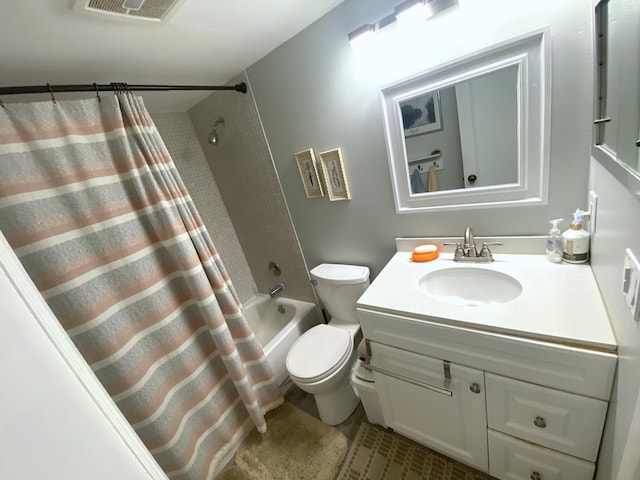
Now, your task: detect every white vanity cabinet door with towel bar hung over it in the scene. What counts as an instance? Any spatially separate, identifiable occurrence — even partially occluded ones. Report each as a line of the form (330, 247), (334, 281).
(371, 342), (489, 472)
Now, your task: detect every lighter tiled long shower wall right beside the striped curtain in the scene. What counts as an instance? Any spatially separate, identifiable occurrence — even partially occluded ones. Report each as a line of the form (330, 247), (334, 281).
(151, 113), (257, 302)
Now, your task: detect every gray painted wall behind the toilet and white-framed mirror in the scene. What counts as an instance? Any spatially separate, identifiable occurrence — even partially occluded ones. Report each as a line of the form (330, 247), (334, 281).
(247, 0), (592, 275)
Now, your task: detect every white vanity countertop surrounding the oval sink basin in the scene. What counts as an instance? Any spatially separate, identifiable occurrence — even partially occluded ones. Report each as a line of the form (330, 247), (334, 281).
(358, 242), (617, 352)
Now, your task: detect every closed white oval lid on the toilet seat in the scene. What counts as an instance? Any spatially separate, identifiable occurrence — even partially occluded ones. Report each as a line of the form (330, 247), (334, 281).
(286, 324), (352, 382)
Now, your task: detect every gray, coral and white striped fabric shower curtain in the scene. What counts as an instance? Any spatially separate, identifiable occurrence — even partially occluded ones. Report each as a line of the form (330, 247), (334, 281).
(0, 93), (283, 480)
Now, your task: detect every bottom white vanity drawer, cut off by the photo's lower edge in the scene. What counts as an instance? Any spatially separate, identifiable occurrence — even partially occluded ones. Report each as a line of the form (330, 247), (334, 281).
(488, 430), (595, 480)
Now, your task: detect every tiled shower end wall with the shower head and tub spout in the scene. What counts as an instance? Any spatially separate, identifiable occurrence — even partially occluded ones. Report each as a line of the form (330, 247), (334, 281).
(189, 75), (315, 302)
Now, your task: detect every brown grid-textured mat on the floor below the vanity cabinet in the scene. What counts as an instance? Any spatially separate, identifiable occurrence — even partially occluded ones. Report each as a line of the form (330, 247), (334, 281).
(338, 423), (493, 480)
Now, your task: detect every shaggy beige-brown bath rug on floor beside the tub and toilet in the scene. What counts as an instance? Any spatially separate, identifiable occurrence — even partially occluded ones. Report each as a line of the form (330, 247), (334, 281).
(217, 403), (348, 480)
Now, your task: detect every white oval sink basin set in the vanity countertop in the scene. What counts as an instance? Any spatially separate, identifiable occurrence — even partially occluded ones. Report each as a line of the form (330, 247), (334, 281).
(419, 267), (522, 306)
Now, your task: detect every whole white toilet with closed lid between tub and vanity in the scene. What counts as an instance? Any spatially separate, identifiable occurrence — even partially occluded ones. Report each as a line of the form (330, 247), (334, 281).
(286, 263), (369, 425)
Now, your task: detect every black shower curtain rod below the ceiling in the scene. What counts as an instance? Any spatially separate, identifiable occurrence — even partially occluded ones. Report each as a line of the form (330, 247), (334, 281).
(0, 82), (247, 96)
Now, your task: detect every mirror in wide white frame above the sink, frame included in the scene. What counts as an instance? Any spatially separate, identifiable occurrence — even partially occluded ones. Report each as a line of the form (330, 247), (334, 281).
(380, 30), (550, 213)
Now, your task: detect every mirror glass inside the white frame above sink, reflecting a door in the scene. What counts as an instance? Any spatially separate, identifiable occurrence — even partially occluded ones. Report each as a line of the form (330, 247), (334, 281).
(399, 65), (518, 195)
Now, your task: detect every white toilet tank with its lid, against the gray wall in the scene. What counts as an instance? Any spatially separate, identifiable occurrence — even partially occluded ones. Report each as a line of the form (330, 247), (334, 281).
(309, 263), (369, 323)
